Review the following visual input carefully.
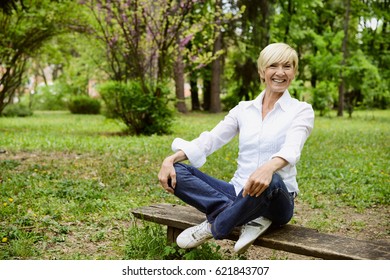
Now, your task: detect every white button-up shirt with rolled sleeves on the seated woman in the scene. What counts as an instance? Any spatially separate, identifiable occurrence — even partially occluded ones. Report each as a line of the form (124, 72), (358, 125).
(172, 90), (314, 194)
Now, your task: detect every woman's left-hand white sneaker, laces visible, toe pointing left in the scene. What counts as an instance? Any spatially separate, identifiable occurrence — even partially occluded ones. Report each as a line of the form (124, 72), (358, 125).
(176, 221), (213, 249)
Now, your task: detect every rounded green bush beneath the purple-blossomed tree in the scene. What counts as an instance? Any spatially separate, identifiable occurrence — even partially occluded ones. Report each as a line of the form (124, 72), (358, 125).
(98, 81), (173, 135)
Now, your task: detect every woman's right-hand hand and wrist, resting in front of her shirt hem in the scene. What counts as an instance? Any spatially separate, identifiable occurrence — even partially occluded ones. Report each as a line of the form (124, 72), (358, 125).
(242, 157), (288, 197)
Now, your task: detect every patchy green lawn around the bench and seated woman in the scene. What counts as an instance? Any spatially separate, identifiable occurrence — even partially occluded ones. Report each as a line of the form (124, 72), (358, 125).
(0, 111), (390, 260)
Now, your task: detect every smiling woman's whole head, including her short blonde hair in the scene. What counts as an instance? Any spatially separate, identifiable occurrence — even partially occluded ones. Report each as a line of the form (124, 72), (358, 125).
(257, 43), (298, 93)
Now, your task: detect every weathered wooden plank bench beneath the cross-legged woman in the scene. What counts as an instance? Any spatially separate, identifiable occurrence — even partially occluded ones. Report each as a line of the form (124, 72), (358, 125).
(132, 204), (390, 260)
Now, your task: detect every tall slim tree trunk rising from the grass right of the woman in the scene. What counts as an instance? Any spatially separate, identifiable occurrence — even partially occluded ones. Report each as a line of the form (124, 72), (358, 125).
(337, 0), (351, 117)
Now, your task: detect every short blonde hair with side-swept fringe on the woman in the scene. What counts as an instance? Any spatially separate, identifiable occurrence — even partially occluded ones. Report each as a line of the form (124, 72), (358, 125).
(257, 43), (298, 83)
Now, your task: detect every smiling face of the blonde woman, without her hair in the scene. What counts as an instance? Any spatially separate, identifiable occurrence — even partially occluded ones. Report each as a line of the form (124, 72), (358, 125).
(264, 62), (295, 93)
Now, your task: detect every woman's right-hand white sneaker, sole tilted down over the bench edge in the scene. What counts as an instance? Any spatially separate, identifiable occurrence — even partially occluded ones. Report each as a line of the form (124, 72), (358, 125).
(234, 217), (272, 254)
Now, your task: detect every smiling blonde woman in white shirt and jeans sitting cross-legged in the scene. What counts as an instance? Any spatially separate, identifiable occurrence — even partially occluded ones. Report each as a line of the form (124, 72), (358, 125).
(158, 43), (314, 254)
